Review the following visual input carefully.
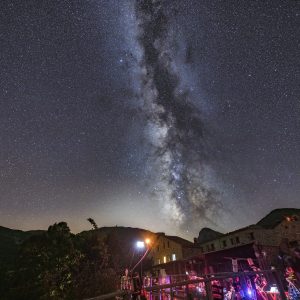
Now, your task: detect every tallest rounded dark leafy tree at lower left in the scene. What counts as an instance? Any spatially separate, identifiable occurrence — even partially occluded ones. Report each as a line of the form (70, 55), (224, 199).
(9, 222), (81, 299)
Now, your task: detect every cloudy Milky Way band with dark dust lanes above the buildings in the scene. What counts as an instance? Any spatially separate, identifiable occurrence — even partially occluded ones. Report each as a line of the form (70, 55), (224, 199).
(130, 0), (222, 231)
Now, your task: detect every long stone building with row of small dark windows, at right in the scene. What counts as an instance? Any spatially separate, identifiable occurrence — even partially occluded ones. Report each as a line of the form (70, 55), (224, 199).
(194, 209), (300, 273)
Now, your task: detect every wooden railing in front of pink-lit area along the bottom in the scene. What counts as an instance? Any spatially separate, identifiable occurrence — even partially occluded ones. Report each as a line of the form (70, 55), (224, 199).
(85, 270), (287, 300)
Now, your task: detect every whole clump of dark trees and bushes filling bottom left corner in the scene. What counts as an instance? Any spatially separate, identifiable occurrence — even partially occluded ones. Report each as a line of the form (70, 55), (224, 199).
(0, 222), (117, 300)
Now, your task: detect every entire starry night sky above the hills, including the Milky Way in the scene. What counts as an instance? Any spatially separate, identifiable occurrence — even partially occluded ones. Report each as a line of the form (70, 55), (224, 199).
(0, 0), (300, 238)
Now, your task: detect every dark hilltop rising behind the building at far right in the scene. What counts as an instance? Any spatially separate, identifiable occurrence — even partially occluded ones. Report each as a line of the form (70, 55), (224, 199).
(256, 208), (300, 229)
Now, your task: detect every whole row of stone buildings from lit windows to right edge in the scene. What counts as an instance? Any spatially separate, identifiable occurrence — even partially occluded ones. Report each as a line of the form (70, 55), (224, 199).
(144, 208), (300, 275)
